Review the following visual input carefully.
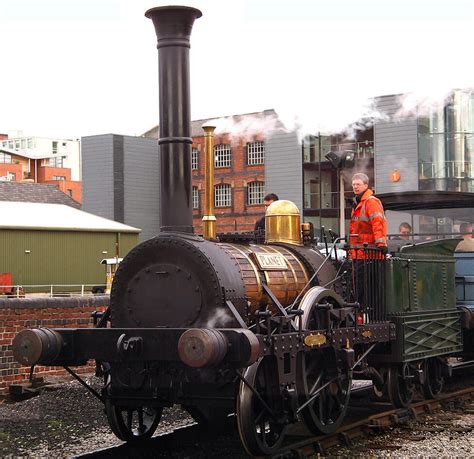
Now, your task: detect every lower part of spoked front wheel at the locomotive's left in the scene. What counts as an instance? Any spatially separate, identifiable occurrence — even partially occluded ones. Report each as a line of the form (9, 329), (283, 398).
(105, 399), (163, 443)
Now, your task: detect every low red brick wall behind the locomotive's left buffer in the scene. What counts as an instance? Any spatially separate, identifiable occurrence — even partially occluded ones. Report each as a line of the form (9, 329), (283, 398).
(0, 306), (105, 395)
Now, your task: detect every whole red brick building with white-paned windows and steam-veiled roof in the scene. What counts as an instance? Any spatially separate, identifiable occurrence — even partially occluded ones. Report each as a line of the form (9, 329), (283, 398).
(144, 110), (281, 234)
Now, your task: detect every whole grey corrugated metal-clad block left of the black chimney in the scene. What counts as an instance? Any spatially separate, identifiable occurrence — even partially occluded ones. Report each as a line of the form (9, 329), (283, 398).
(82, 134), (160, 241)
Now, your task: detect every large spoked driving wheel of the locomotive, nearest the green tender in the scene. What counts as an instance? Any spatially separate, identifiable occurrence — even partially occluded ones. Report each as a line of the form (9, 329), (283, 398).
(296, 287), (352, 434)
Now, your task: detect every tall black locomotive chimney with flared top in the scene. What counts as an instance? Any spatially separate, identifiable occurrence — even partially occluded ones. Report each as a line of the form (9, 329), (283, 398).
(145, 6), (202, 233)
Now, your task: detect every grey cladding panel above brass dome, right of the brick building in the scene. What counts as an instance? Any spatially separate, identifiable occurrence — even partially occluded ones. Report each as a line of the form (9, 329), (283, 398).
(265, 130), (303, 213)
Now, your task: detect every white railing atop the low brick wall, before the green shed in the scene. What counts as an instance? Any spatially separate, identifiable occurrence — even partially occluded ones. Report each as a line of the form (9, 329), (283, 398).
(0, 284), (105, 298)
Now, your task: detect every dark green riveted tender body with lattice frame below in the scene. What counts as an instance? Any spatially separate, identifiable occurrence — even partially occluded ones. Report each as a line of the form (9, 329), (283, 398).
(385, 239), (462, 362)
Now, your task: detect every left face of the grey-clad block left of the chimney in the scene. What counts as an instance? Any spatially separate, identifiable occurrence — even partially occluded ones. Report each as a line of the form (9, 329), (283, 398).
(81, 134), (114, 220)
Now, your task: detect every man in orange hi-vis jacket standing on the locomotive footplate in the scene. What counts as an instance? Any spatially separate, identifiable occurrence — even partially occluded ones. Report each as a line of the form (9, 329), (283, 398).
(349, 173), (387, 307)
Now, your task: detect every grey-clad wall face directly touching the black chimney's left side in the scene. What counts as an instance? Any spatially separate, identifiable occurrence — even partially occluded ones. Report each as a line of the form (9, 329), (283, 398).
(123, 136), (160, 241)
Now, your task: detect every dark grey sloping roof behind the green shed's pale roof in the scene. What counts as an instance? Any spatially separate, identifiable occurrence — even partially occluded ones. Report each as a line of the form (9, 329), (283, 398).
(0, 182), (81, 209)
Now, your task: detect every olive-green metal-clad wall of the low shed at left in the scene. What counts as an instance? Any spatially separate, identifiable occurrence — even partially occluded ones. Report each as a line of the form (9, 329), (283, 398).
(0, 230), (138, 292)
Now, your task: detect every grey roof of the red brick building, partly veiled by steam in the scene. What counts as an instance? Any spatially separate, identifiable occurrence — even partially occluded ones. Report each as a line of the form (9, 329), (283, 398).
(142, 109), (283, 139)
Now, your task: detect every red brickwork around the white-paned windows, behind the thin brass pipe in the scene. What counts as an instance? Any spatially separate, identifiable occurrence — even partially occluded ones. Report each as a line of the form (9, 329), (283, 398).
(192, 134), (265, 234)
